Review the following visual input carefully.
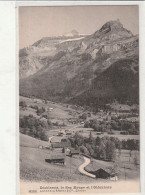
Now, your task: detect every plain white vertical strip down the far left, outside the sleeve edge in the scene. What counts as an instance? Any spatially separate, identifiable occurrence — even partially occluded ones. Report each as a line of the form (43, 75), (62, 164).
(0, 1), (17, 195)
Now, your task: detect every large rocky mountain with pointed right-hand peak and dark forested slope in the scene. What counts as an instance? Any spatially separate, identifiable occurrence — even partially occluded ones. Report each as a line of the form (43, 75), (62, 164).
(20, 20), (139, 106)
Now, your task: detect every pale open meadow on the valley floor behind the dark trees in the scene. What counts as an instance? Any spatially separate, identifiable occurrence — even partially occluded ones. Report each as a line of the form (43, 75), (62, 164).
(20, 96), (139, 140)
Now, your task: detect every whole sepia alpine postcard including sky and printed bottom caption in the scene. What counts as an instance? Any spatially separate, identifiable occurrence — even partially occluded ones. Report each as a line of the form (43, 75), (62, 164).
(18, 5), (140, 195)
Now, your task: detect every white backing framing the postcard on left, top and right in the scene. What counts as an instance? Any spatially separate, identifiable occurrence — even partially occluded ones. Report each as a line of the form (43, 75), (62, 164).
(0, 1), (145, 195)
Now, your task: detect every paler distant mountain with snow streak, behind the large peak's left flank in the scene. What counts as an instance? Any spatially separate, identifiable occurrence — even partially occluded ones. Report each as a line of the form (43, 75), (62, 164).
(19, 30), (85, 79)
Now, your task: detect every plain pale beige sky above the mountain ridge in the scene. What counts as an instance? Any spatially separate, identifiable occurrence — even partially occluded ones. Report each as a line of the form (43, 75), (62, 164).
(19, 5), (139, 49)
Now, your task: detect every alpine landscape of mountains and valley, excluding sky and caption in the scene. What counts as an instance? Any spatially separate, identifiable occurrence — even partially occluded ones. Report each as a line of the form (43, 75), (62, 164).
(19, 19), (140, 183)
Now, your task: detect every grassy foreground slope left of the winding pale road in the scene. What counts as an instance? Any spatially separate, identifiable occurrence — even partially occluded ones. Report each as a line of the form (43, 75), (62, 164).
(20, 134), (94, 182)
